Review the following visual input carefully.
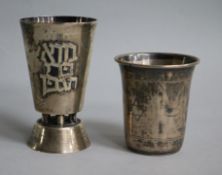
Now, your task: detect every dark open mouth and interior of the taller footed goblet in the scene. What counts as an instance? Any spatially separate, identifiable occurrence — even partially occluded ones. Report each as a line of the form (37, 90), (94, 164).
(20, 16), (96, 23)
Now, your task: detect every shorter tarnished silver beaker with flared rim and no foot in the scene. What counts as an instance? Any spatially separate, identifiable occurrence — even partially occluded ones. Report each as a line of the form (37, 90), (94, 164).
(116, 53), (198, 154)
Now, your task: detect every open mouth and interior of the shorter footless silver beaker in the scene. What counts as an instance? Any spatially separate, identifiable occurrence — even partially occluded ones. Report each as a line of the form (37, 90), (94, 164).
(115, 53), (199, 68)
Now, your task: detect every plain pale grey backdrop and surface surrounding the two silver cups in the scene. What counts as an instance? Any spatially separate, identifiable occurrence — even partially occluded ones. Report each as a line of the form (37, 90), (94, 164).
(0, 0), (222, 175)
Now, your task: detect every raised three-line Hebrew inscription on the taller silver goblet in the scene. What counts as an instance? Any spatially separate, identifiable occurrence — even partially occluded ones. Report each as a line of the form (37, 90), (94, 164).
(38, 41), (78, 96)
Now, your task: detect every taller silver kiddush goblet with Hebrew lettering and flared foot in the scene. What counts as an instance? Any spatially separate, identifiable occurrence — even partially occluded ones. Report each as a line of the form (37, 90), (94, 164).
(20, 16), (97, 153)
